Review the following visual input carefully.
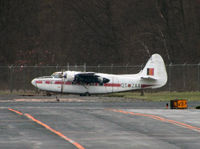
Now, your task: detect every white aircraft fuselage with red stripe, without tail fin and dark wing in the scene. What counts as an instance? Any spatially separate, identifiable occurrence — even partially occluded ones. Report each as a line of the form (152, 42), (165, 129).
(32, 74), (155, 94)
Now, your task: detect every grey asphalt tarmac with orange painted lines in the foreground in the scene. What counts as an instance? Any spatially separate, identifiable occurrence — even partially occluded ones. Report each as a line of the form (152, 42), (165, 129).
(0, 96), (200, 149)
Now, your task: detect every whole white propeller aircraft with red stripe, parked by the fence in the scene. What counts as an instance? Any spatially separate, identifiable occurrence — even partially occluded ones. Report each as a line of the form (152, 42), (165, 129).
(31, 54), (167, 95)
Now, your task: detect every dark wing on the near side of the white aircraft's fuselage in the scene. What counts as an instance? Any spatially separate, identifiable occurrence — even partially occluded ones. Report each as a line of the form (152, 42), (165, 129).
(73, 72), (110, 85)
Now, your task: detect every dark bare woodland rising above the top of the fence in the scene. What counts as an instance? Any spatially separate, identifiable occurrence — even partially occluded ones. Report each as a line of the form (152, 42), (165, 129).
(0, 0), (200, 65)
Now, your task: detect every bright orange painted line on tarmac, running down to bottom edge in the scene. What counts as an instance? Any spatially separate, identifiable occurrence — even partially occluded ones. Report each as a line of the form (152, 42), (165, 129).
(8, 108), (85, 149)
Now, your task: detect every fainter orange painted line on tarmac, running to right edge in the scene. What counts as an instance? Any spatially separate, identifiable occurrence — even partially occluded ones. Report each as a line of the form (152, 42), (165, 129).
(108, 109), (200, 132)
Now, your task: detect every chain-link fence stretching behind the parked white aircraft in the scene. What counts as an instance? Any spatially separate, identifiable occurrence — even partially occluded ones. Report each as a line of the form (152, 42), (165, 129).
(0, 64), (200, 92)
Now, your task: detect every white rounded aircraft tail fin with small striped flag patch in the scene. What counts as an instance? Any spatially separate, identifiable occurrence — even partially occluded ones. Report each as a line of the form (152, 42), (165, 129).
(141, 54), (167, 88)
